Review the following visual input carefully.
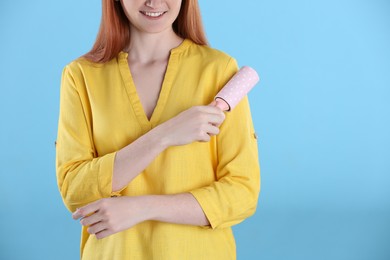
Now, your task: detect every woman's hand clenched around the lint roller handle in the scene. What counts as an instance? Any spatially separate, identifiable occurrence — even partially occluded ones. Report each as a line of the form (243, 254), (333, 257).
(154, 101), (225, 147)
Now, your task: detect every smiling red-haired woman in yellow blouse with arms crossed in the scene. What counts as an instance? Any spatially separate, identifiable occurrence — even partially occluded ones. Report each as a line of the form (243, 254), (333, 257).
(56, 0), (260, 259)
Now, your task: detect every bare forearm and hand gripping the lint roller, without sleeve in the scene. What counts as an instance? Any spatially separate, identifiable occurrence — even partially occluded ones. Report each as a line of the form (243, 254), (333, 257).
(112, 101), (225, 191)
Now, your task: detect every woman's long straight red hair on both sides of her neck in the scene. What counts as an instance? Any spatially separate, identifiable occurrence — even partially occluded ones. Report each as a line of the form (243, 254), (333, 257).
(83, 0), (208, 63)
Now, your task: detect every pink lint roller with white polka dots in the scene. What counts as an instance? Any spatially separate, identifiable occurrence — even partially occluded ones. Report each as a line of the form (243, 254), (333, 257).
(214, 66), (260, 111)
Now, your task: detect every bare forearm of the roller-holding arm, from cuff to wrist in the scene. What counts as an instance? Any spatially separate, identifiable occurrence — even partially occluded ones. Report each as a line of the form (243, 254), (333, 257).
(112, 128), (168, 191)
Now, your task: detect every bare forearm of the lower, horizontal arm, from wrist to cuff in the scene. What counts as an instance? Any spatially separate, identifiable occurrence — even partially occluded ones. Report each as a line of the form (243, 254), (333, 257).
(141, 193), (210, 226)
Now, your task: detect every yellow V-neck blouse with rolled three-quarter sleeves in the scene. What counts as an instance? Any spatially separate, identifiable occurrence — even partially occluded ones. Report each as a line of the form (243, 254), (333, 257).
(56, 40), (260, 260)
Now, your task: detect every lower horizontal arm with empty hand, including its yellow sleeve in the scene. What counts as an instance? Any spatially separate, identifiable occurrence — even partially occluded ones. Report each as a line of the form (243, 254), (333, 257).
(73, 95), (260, 238)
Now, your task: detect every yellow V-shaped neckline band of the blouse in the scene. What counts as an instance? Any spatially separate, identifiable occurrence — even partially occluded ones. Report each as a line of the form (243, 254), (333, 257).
(118, 39), (189, 130)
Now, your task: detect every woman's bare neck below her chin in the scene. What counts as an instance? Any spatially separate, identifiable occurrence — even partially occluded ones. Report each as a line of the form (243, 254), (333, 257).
(127, 29), (183, 64)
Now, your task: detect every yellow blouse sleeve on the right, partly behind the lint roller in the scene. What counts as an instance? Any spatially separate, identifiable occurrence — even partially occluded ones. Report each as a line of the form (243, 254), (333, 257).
(190, 59), (260, 229)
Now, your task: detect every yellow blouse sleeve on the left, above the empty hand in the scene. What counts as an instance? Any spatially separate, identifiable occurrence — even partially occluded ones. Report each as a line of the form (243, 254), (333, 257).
(56, 66), (119, 212)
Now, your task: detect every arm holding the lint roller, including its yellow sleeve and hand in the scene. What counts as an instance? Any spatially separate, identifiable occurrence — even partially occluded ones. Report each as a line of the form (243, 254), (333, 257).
(56, 64), (224, 212)
